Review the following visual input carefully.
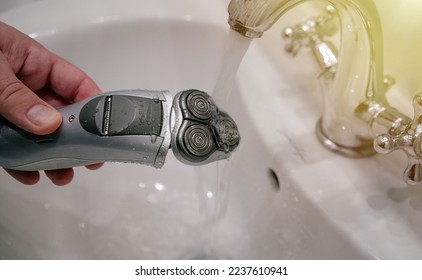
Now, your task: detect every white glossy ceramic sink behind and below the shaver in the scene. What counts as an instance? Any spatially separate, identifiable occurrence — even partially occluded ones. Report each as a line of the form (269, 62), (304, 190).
(0, 0), (422, 259)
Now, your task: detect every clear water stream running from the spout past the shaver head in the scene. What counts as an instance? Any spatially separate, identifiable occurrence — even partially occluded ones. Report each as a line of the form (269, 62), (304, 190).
(197, 29), (252, 257)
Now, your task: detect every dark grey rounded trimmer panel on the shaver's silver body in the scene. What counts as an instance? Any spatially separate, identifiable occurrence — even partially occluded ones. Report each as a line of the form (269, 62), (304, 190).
(79, 95), (163, 136)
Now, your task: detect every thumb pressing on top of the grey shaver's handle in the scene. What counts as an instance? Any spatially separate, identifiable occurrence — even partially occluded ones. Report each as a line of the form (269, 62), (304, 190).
(0, 77), (62, 135)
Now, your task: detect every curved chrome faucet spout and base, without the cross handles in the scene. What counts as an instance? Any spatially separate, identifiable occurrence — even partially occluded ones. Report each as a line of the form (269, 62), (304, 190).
(228, 0), (400, 157)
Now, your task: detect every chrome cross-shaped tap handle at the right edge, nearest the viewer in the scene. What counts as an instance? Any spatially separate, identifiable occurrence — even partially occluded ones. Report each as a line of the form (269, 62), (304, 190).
(374, 94), (422, 185)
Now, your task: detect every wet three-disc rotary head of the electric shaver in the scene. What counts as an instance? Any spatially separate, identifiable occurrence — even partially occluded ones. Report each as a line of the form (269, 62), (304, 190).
(171, 89), (240, 165)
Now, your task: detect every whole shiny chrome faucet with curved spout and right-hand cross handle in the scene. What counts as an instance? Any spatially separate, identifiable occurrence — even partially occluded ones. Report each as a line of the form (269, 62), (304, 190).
(228, 0), (422, 185)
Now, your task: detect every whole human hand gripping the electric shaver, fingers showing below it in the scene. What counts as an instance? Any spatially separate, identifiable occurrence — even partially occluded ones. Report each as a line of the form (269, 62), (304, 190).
(0, 22), (101, 185)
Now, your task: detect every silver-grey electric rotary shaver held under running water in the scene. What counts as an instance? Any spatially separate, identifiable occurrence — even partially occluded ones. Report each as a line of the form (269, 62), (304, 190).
(0, 90), (240, 171)
